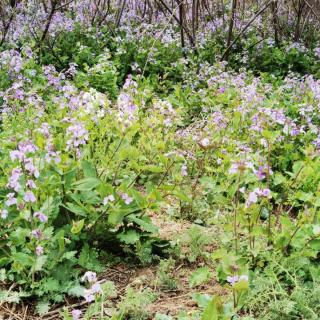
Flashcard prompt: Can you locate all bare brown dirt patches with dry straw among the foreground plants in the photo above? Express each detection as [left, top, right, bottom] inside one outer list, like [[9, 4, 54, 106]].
[[0, 216, 226, 320]]
